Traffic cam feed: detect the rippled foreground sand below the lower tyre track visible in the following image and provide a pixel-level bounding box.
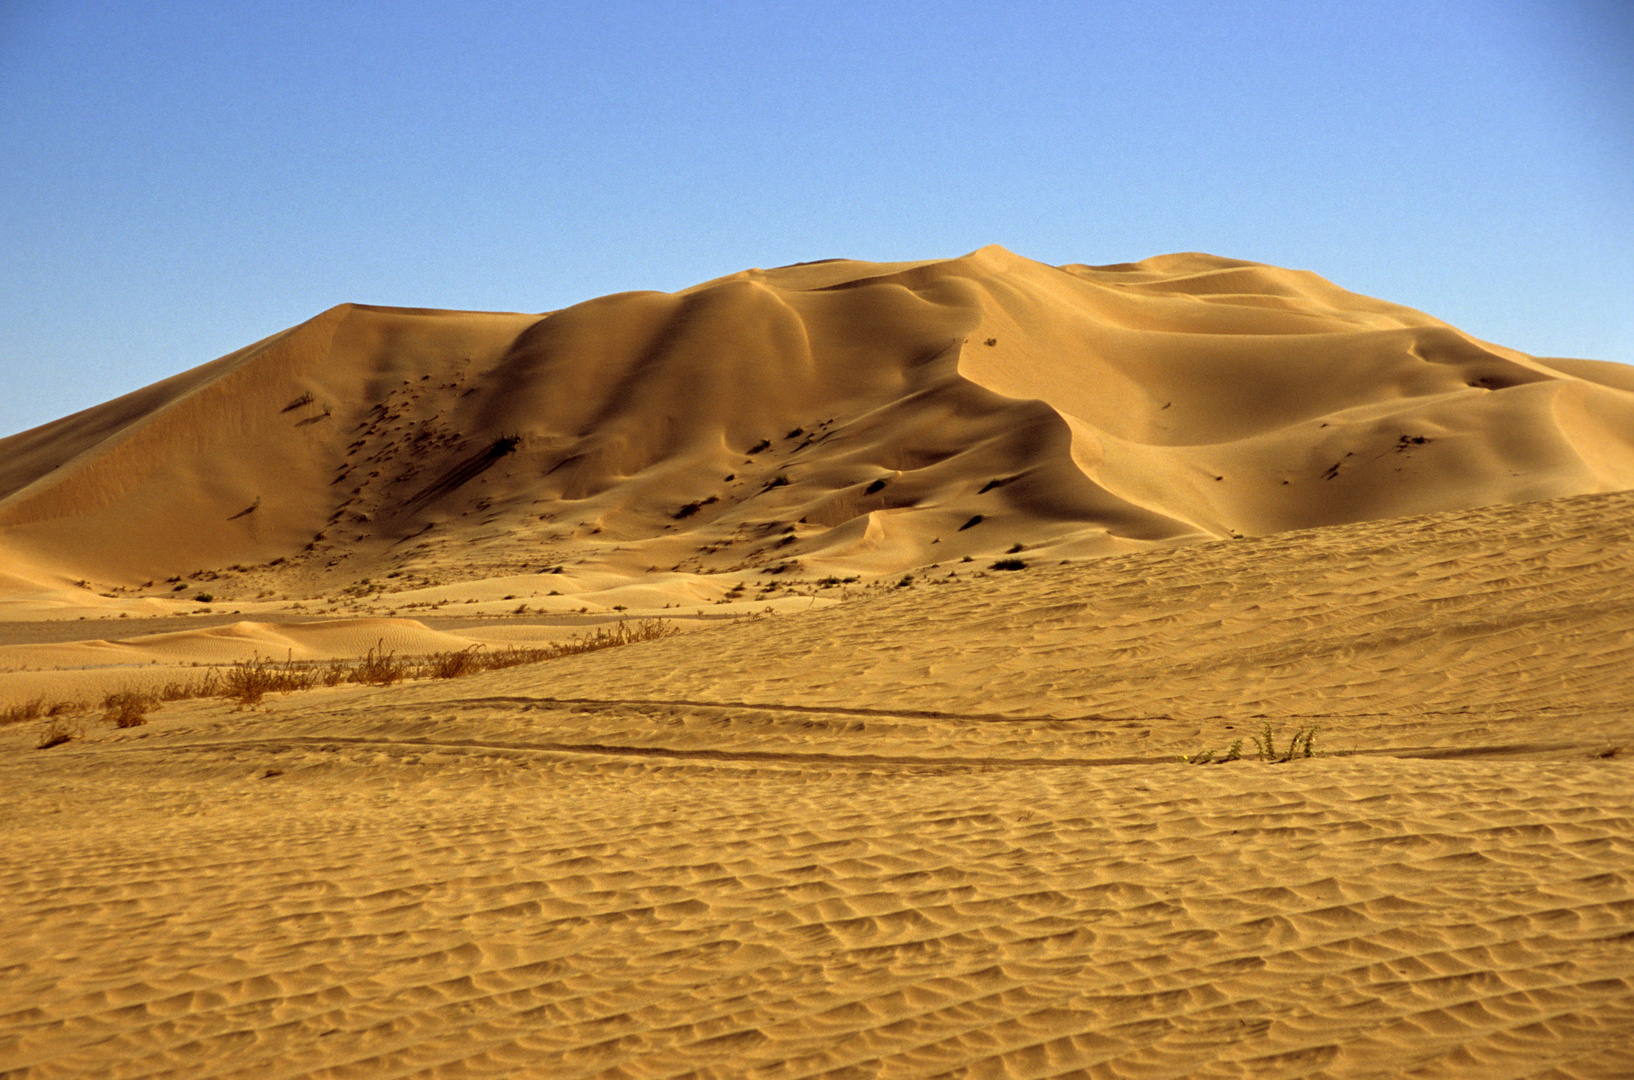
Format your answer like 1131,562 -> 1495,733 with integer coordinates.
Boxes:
0,754 -> 1634,1078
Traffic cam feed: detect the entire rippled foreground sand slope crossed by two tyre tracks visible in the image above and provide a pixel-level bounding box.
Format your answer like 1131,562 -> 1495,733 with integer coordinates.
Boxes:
0,493 -> 1634,1080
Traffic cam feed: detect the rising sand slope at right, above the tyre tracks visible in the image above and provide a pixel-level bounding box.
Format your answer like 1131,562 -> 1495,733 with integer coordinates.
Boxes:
450,492 -> 1634,748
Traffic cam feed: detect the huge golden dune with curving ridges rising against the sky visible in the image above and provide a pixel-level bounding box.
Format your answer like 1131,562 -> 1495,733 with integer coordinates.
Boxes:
0,247 -> 1634,594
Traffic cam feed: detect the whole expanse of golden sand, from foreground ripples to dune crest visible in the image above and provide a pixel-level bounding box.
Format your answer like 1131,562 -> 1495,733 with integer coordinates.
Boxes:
0,248 -> 1634,1080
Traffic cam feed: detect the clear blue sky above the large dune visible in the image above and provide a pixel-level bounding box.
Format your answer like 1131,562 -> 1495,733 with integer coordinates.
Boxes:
0,0 -> 1634,435
